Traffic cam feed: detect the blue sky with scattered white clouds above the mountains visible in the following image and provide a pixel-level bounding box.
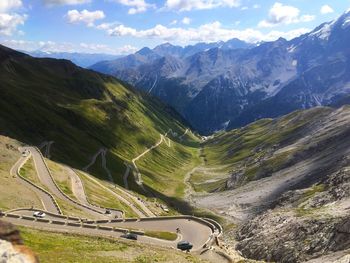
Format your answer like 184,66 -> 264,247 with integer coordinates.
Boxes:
0,0 -> 350,55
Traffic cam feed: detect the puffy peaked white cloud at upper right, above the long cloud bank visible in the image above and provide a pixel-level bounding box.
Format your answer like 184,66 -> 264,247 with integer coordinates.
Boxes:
258,2 -> 315,27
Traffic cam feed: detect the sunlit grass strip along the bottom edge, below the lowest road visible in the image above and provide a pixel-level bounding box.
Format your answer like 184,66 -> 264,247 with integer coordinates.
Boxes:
20,227 -> 207,263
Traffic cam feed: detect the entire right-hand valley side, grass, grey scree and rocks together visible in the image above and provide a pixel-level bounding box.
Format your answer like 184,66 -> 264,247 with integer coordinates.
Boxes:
189,106 -> 350,262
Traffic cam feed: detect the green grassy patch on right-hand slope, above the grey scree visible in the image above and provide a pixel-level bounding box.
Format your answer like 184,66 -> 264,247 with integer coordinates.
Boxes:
198,108 -> 332,192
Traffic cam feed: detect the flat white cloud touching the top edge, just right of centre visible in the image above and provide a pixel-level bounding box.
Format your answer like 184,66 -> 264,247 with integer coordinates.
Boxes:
164,0 -> 240,12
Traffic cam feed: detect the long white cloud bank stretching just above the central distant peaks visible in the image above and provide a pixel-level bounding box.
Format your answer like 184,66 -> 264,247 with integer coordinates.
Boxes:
103,21 -> 310,44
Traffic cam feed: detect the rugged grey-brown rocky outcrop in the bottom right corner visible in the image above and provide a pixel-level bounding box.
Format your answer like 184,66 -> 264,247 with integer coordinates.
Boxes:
237,168 -> 350,262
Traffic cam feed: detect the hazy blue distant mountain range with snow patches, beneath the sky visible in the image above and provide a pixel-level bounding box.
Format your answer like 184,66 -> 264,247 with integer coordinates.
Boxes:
91,11 -> 350,134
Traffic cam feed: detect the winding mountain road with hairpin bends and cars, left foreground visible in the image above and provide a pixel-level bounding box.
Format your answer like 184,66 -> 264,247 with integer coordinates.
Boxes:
6,147 -> 216,253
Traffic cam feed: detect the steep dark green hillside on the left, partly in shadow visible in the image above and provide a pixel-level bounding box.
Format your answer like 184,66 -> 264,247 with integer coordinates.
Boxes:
0,44 -> 198,204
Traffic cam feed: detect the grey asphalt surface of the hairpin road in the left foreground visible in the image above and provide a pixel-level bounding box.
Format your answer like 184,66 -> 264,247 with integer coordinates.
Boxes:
3,147 -> 217,250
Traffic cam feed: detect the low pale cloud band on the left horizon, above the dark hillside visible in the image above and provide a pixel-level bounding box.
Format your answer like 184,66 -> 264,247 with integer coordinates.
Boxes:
1,39 -> 138,55
